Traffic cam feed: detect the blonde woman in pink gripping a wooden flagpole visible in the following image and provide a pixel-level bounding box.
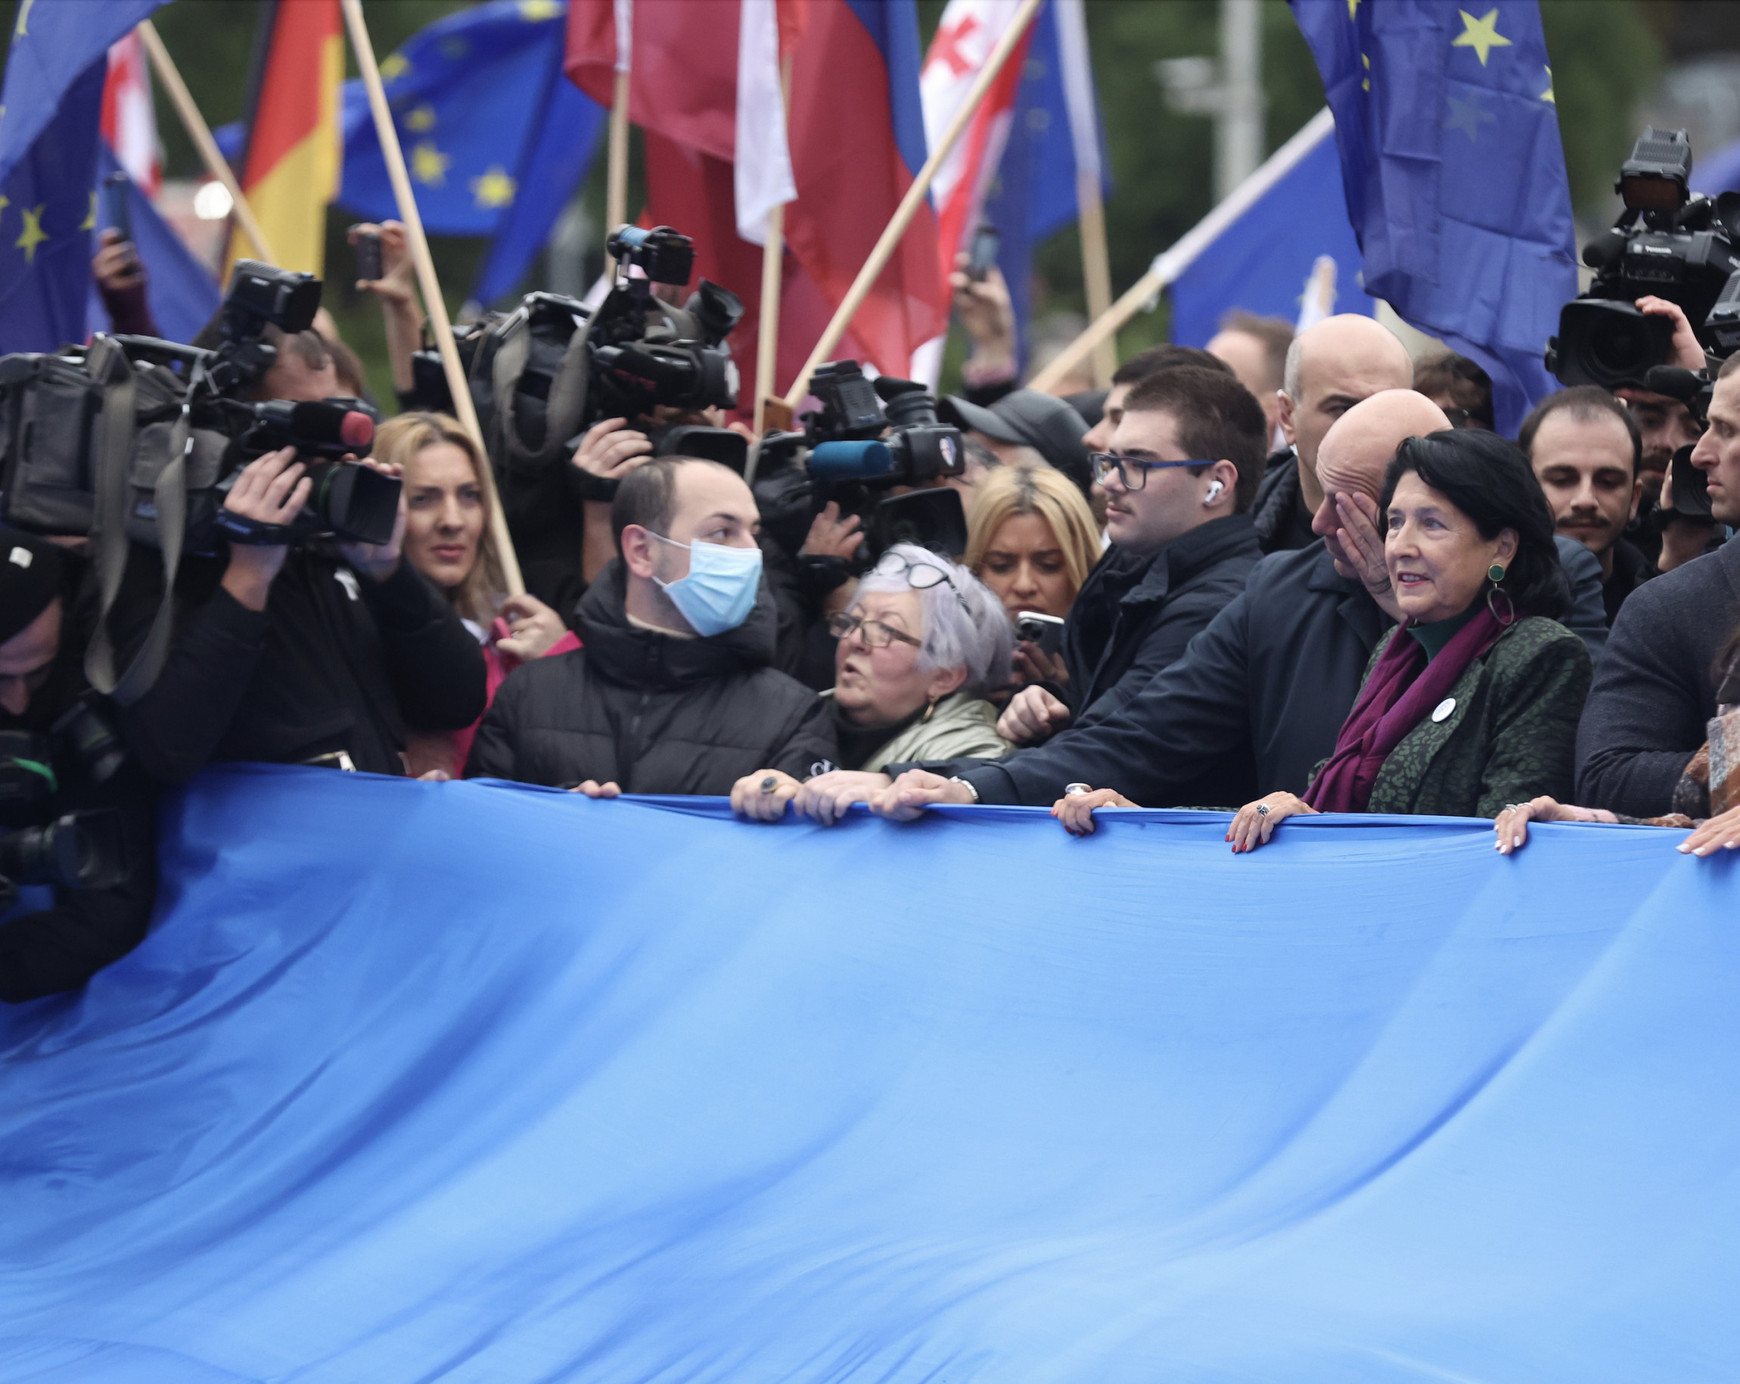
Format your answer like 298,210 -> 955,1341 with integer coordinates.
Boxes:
374,413 -> 579,778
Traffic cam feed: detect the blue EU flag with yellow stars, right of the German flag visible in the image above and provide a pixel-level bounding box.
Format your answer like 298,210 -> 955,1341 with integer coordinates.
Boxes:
339,0 -> 606,303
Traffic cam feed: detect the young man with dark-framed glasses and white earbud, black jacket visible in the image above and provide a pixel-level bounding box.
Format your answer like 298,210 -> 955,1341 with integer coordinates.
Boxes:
997,366 -> 1267,745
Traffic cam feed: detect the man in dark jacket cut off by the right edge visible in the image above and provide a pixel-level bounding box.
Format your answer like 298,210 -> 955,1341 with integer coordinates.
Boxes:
1576,355 -> 1740,816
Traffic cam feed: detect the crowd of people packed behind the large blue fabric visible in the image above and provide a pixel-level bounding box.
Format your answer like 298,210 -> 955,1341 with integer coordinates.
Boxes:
0,225 -> 1740,1001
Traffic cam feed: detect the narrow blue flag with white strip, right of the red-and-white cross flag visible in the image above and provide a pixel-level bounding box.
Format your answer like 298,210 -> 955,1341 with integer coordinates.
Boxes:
981,0 -> 1112,362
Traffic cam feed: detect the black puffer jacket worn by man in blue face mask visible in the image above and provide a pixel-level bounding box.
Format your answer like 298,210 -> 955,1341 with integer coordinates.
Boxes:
465,559 -> 835,794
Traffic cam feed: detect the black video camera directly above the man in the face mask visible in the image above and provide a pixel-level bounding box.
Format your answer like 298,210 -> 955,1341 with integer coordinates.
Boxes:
412,226 -> 746,474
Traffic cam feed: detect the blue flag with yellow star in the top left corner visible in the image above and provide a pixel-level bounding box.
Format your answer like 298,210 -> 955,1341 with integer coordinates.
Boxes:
0,0 -> 162,353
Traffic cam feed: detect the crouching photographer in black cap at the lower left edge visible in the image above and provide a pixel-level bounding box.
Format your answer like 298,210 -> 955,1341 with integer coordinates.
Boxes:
0,529 -> 157,1003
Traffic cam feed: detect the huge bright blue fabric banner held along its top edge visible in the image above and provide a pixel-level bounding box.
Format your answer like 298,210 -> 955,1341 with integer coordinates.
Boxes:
0,769 -> 1740,1384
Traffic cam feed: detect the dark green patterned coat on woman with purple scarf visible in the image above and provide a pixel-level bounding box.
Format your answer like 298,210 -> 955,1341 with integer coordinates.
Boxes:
1314,616 -> 1594,816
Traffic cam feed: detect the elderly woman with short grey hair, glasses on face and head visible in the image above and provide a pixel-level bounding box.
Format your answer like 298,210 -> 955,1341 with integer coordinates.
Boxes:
731,543 -> 1014,823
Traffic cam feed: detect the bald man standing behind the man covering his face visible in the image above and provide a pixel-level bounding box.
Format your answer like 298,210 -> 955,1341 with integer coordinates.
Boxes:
1251,313 -> 1413,552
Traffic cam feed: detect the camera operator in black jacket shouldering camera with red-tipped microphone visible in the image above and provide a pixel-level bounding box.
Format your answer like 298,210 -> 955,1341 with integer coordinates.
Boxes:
110,447 -> 487,783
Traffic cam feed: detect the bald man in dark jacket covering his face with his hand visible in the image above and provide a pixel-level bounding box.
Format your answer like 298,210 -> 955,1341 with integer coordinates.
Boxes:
870,390 -> 1606,818
